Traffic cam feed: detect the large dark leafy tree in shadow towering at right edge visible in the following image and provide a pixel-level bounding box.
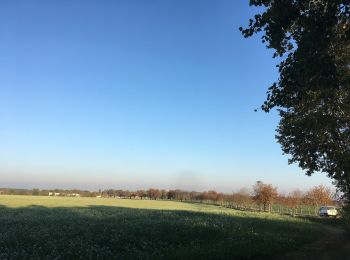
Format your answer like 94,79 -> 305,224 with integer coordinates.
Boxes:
240,0 -> 350,203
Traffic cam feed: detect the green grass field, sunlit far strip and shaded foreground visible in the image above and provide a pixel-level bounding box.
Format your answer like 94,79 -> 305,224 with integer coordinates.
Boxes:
0,195 -> 328,259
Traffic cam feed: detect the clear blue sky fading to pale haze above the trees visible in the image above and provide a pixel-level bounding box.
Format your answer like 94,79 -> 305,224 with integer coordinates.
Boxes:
0,0 -> 331,192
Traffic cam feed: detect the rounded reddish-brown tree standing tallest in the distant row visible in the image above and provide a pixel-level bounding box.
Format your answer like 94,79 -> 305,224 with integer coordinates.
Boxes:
253,181 -> 278,212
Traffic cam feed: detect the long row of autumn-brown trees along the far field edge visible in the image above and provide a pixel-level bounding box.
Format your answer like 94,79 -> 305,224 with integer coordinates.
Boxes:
0,181 -> 335,215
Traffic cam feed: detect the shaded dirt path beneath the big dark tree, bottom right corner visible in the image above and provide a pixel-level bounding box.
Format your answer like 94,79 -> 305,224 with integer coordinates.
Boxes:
277,226 -> 350,260
